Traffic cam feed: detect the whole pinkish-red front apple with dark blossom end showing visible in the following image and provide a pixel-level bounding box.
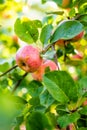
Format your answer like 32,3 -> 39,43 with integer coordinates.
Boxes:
16,45 -> 42,72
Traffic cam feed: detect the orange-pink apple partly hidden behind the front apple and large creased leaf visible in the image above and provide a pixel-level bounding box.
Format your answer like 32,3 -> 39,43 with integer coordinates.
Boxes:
32,60 -> 58,81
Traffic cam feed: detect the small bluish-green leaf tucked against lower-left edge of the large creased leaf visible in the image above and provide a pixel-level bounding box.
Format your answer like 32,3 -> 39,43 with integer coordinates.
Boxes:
40,90 -> 54,108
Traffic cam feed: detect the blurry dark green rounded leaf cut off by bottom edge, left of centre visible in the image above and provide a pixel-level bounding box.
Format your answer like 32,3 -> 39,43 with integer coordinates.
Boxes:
26,112 -> 52,130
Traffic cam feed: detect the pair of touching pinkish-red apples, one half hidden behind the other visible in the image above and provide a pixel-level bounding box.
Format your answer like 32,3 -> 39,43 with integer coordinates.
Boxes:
16,45 -> 58,81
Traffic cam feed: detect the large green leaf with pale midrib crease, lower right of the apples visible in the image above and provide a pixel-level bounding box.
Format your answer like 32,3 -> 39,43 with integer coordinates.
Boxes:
43,71 -> 78,103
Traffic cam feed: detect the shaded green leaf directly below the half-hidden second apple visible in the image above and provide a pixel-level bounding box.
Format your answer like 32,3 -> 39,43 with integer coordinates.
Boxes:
27,80 -> 43,97
